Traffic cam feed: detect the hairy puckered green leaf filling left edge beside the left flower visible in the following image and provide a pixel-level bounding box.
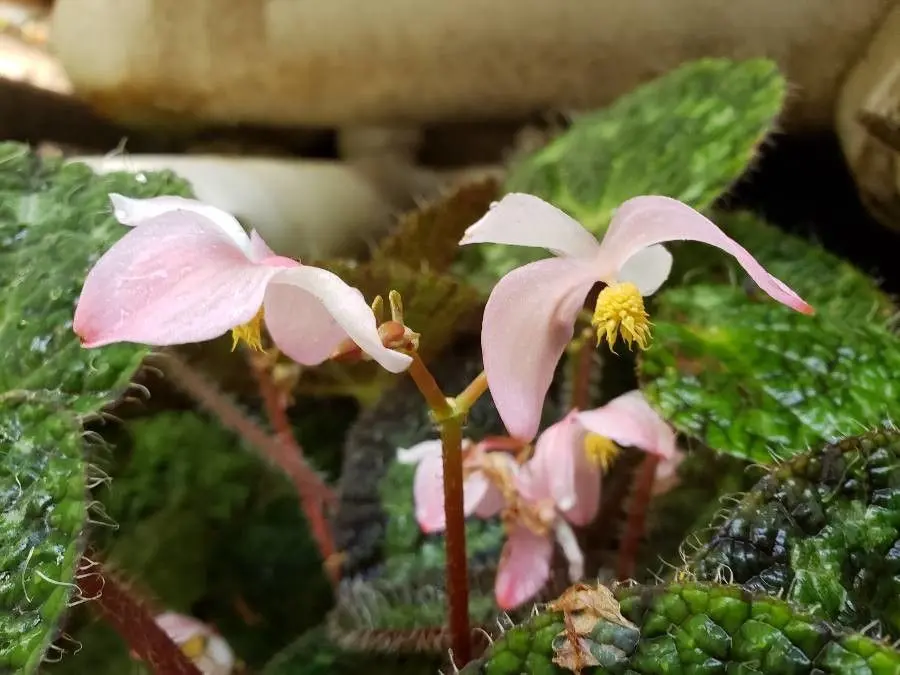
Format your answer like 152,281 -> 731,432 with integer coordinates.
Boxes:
0,143 -> 195,673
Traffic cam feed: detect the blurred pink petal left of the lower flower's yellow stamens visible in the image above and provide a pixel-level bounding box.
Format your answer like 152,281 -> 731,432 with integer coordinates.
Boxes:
519,411 -> 600,525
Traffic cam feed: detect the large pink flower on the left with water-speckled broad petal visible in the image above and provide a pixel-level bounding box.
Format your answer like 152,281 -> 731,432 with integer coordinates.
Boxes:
73,194 -> 411,373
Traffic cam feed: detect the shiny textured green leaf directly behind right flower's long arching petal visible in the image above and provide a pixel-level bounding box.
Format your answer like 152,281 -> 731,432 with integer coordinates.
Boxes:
639,214 -> 900,463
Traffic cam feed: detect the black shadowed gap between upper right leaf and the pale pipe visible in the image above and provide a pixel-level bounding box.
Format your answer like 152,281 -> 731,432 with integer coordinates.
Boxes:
722,133 -> 900,294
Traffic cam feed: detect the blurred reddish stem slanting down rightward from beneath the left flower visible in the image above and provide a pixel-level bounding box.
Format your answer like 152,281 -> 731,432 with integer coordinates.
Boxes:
156,352 -> 338,579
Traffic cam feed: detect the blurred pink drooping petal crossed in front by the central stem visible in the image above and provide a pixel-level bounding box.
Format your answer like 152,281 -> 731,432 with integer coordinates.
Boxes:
413,448 -> 503,534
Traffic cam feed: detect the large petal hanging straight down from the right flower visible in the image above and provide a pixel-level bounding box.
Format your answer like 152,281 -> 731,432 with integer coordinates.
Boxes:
481,258 -> 597,442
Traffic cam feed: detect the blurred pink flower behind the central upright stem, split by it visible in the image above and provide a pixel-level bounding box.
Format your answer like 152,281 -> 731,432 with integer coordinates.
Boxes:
397,439 -> 515,534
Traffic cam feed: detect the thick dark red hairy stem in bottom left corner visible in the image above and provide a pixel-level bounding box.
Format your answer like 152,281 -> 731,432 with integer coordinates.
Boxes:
76,551 -> 202,675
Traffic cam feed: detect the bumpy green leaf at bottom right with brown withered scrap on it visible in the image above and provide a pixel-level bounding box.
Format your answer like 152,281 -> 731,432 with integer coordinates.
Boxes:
460,583 -> 900,675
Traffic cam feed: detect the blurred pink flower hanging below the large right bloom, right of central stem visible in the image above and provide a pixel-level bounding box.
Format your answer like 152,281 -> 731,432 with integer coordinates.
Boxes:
495,391 -> 680,609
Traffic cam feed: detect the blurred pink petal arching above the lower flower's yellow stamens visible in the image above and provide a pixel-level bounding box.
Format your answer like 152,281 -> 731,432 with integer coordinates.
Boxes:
578,389 -> 676,458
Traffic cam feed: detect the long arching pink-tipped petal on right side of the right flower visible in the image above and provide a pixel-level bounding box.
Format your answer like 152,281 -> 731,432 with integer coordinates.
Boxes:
601,196 -> 814,314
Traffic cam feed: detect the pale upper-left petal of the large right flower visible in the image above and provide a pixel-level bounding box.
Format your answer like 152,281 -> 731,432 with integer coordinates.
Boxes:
459,192 -> 600,258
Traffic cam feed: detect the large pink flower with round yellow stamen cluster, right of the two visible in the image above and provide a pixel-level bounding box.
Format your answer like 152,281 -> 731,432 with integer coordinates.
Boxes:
460,193 -> 813,441
